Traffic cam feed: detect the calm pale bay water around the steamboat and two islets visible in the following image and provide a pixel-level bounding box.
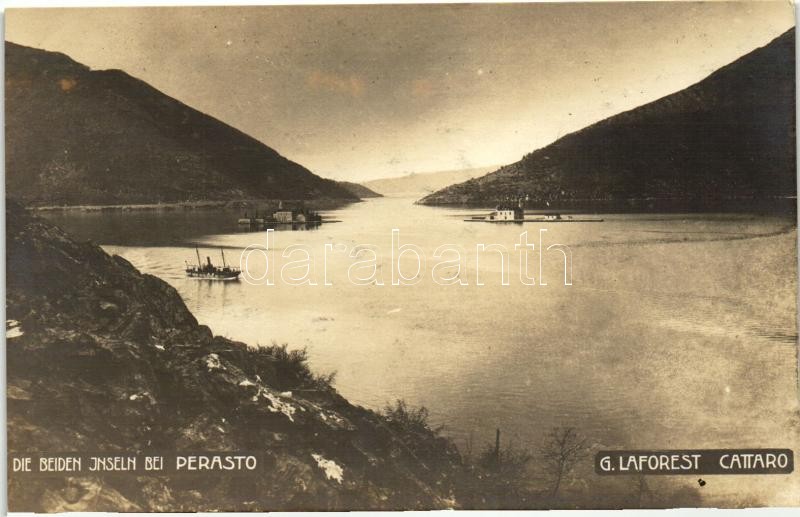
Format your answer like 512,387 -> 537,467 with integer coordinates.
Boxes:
47,198 -> 800,504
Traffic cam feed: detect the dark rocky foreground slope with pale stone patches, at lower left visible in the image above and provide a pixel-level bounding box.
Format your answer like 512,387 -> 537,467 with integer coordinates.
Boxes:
6,202 -> 461,512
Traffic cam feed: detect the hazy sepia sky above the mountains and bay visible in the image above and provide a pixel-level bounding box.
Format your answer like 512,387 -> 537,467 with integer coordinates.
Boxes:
6,1 -> 794,180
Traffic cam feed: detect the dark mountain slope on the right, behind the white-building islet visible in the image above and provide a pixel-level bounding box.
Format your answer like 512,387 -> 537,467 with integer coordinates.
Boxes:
420,29 -> 796,210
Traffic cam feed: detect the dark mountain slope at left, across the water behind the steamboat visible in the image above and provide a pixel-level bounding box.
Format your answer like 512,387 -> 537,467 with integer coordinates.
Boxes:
6,42 -> 355,204
